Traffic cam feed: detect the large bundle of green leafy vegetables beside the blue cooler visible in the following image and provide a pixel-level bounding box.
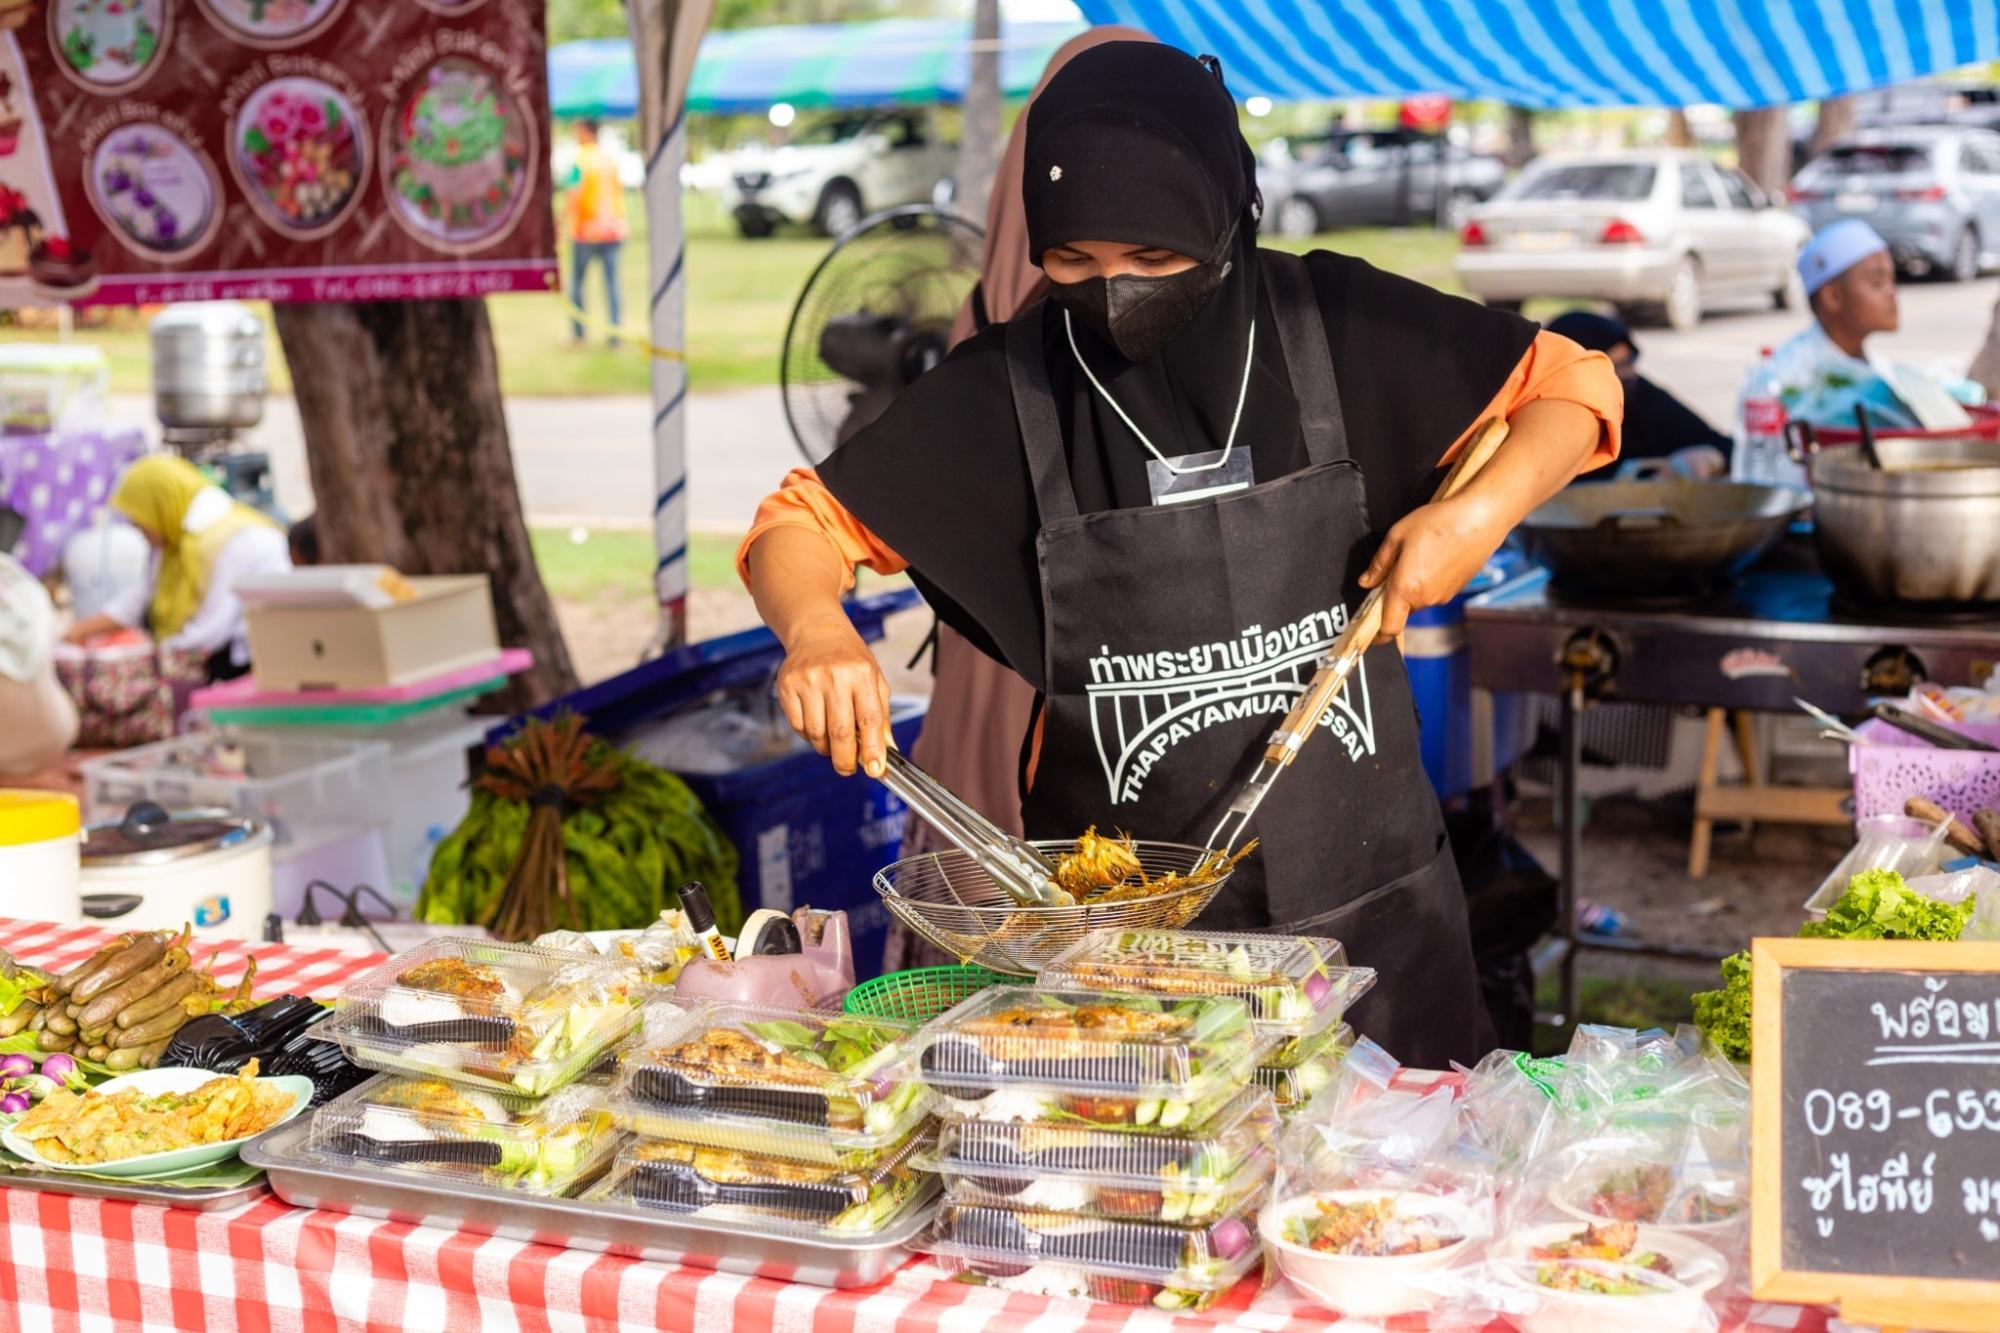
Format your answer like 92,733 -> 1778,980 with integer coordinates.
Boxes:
416,719 -> 742,939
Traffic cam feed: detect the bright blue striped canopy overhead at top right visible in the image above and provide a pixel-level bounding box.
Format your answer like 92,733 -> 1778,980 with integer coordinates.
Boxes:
1078,0 -> 2000,108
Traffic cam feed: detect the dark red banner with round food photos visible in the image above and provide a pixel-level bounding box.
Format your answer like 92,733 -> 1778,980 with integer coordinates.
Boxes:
0,0 -> 556,306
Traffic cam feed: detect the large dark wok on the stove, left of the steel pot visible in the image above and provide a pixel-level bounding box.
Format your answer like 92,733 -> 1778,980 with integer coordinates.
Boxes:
1520,480 -> 1812,596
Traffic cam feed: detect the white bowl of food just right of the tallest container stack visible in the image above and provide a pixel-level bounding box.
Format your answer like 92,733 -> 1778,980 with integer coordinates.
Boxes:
1258,1189 -> 1482,1319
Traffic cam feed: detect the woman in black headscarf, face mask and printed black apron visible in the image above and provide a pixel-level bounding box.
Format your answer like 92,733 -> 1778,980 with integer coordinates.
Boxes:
738,42 -> 1620,1067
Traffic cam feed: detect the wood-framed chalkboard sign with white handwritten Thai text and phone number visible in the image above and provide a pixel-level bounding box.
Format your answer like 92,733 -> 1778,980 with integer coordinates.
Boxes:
1750,941 -> 2000,1329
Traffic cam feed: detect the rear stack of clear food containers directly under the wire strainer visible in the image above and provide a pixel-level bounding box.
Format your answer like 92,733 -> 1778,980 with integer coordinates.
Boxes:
1040,931 -> 1376,1119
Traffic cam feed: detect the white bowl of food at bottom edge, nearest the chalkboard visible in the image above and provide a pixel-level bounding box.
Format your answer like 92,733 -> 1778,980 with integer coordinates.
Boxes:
1496,1223 -> 1728,1333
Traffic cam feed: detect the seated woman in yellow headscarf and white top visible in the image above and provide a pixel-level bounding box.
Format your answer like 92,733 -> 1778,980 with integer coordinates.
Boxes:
66,454 -> 292,681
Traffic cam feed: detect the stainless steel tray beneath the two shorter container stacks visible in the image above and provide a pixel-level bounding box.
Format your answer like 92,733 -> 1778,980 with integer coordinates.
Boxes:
244,1121 -> 936,1287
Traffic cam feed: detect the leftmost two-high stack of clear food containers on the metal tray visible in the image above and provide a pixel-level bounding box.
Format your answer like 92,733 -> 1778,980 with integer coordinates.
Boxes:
306,939 -> 660,1197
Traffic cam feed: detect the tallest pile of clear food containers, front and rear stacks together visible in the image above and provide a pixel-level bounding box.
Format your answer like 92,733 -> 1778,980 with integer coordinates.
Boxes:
922,931 -> 1374,1309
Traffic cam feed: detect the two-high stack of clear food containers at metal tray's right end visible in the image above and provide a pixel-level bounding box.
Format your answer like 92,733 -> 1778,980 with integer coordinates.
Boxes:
590,1005 -> 936,1243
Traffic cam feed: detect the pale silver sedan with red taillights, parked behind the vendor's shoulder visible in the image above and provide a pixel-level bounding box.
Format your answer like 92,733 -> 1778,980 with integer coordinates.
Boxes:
1454,148 -> 1810,328
